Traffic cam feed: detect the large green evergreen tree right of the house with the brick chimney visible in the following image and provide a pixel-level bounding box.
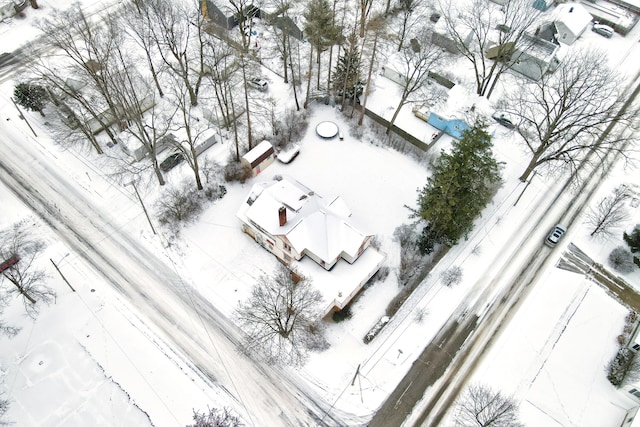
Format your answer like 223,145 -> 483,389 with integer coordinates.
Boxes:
414,122 -> 501,253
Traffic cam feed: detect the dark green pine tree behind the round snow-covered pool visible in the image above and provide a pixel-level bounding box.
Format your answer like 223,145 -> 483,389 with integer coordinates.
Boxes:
333,33 -> 364,104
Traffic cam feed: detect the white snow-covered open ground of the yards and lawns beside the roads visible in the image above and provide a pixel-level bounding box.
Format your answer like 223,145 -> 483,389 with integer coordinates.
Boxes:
0,0 -> 640,427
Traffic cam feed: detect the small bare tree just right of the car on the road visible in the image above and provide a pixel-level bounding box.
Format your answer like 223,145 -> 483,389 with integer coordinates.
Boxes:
586,186 -> 629,237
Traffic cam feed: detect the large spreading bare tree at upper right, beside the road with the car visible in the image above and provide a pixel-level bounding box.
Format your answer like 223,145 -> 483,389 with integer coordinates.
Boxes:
505,50 -> 631,181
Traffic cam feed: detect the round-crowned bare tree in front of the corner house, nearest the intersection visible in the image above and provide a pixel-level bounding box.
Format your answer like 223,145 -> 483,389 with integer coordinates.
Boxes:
236,265 -> 328,365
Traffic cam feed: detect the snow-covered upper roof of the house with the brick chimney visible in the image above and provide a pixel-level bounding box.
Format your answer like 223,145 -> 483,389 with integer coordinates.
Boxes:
238,177 -> 371,264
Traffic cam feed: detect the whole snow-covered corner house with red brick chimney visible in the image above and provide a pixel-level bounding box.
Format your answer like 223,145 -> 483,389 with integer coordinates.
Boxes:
237,177 -> 385,313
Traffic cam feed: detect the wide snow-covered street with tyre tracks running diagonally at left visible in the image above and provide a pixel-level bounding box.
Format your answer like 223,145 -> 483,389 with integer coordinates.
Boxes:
0,122 -> 346,427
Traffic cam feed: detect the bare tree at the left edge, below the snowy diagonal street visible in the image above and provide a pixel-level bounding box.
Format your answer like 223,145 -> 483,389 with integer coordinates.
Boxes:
0,221 -> 55,317
